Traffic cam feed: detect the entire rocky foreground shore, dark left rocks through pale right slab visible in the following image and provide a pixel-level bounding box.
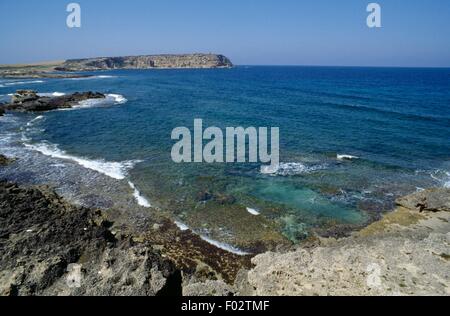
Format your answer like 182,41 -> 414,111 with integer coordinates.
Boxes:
0,152 -> 450,296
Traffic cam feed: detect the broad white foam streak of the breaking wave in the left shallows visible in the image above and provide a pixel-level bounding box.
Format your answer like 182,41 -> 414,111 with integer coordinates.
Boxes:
24,142 -> 140,180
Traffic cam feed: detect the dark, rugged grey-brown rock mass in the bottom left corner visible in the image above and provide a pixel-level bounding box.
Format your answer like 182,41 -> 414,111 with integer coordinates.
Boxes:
0,181 -> 181,295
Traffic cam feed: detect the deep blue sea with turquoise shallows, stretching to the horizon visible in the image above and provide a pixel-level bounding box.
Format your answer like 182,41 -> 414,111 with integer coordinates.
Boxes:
0,66 -> 450,248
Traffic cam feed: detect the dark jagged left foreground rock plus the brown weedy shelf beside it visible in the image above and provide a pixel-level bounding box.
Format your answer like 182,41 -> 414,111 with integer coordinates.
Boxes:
0,181 -> 250,296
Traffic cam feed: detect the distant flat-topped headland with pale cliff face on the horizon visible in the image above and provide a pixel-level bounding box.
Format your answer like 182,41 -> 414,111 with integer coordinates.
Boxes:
56,54 -> 233,71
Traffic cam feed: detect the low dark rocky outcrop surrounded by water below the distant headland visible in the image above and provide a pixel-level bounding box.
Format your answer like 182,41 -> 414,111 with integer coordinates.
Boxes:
4,90 -> 105,112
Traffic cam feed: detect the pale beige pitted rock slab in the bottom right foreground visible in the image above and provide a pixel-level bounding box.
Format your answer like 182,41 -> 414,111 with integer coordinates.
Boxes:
232,189 -> 450,296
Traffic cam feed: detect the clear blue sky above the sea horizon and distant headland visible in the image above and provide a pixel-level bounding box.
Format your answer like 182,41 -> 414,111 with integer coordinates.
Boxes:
0,0 -> 450,67
